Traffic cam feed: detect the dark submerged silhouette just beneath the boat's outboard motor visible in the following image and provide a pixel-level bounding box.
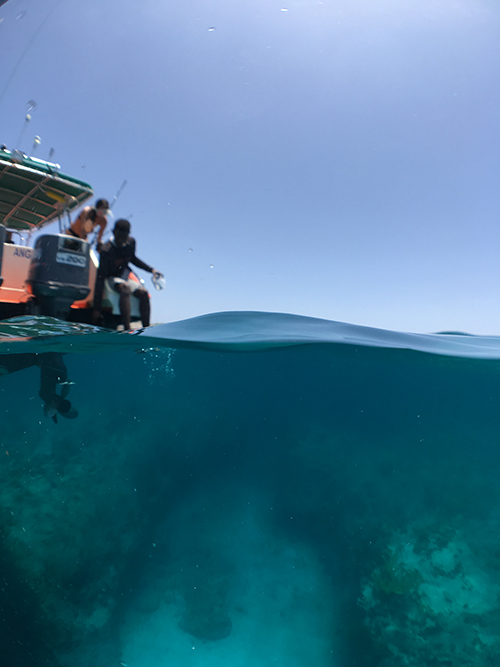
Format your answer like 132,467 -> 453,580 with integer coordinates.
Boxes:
0,352 -> 78,424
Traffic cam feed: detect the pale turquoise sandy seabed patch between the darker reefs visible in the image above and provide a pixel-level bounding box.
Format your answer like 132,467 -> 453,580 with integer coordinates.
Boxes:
121,488 -> 338,667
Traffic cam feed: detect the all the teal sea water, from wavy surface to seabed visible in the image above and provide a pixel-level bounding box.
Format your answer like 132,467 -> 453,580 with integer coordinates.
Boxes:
0,313 -> 500,667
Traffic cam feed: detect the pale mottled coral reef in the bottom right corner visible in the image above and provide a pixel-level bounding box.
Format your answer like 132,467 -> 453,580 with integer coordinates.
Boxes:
359,525 -> 500,667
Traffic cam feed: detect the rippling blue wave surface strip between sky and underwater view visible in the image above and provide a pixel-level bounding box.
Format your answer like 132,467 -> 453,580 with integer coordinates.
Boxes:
0,311 -> 500,359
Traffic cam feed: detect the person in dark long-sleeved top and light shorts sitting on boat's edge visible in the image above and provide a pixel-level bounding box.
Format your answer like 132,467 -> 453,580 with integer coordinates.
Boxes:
92,218 -> 163,330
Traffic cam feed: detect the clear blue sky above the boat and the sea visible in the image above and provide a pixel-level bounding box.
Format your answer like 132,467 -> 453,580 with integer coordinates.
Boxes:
0,0 -> 500,335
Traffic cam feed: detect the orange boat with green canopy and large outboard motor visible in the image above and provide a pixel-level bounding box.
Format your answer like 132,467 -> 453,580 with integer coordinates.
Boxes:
0,147 -> 144,328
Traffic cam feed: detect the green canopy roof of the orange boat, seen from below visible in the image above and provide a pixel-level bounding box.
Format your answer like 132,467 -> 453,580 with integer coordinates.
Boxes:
0,150 -> 94,231
